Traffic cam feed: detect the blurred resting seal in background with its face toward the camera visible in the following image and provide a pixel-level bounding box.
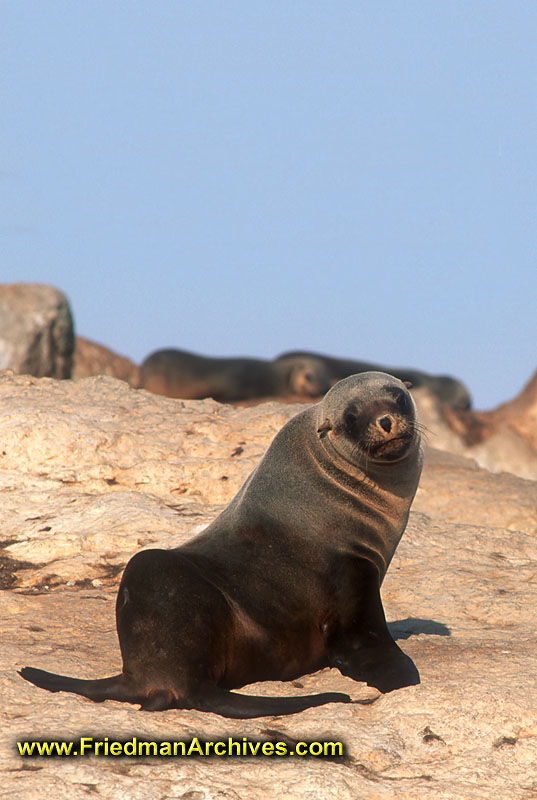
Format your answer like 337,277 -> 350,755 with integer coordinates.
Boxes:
139,349 -> 332,403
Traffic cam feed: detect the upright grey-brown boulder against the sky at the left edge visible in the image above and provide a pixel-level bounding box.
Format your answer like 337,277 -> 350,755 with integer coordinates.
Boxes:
0,283 -> 74,379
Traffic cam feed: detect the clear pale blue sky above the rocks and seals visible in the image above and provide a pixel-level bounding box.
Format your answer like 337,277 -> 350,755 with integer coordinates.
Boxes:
0,0 -> 537,408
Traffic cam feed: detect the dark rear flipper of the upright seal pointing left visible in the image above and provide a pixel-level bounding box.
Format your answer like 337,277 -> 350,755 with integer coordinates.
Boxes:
19,667 -> 142,703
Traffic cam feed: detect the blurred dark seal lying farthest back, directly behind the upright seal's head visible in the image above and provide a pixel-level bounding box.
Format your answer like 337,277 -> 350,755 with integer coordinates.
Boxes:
275,350 -> 472,410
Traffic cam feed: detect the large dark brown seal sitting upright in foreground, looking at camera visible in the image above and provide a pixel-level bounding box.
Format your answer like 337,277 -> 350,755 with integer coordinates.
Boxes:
20,372 -> 422,718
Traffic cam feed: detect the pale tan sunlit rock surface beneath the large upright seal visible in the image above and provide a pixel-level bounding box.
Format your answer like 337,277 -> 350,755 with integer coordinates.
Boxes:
0,374 -> 537,800
